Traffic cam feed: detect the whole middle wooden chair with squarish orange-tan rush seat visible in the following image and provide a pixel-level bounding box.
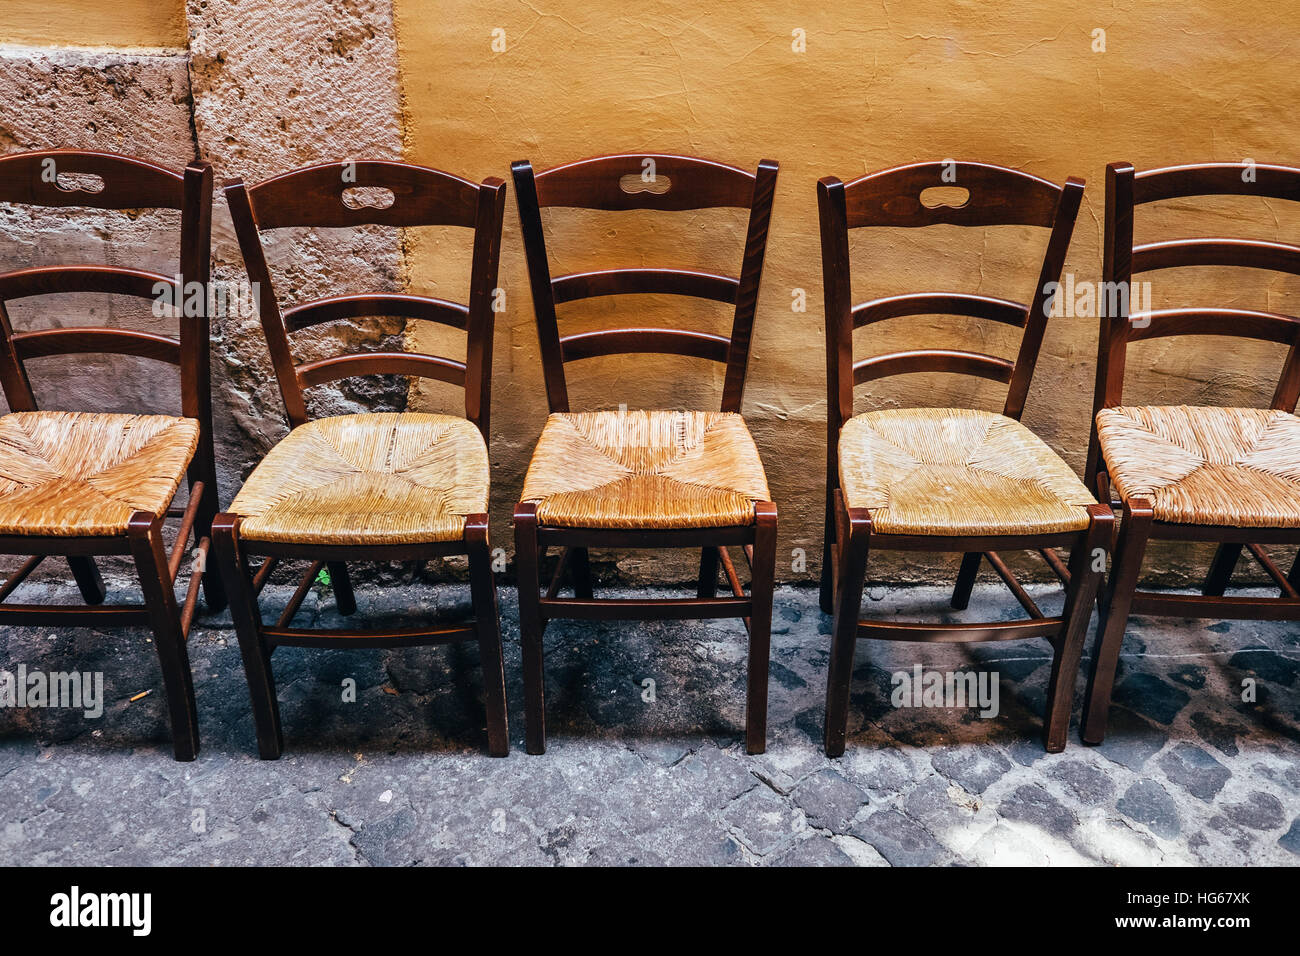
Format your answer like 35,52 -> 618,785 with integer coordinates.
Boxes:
512,153 -> 777,753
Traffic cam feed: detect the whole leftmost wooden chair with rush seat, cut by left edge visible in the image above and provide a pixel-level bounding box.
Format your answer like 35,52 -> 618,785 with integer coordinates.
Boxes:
0,150 -> 225,760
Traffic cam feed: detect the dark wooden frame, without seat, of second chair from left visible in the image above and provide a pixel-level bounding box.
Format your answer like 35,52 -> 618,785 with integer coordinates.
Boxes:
212,160 -> 510,760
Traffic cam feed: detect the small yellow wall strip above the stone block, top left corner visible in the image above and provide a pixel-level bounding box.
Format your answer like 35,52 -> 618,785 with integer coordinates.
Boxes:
0,0 -> 186,47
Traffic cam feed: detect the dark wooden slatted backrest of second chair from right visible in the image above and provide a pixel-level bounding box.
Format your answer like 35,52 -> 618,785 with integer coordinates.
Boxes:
818,160 -> 1084,440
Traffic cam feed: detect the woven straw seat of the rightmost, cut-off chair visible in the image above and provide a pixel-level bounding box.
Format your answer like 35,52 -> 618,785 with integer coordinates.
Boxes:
1097,406 -> 1300,528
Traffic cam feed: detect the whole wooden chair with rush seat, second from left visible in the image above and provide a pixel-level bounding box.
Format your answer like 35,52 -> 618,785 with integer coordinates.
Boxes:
213,161 -> 510,760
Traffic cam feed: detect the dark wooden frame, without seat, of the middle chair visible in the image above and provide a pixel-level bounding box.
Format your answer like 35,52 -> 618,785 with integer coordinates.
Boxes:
512,153 -> 777,754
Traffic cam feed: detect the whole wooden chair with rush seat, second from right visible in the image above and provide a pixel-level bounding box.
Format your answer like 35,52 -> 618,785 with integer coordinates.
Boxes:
818,163 -> 1113,757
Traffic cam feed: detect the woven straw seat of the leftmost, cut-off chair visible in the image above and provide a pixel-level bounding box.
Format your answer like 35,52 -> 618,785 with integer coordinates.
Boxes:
0,411 -> 199,537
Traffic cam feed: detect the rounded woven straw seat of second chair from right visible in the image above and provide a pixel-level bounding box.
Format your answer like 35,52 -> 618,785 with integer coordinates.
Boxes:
840,408 -> 1096,535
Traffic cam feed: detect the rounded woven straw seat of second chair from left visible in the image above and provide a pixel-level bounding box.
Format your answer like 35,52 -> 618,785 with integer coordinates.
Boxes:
230,412 -> 488,545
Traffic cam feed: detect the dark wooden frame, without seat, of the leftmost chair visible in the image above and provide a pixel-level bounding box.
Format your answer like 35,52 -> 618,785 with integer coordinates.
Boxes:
0,150 -> 226,761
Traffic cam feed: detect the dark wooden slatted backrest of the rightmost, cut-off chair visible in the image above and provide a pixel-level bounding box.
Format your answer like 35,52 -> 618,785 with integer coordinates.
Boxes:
1093,163 -> 1300,416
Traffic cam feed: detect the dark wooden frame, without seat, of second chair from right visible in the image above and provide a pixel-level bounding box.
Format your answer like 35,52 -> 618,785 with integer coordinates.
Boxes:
818,163 -> 1114,757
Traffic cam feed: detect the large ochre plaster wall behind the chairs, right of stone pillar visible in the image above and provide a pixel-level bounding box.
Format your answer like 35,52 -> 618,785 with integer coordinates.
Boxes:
395,0 -> 1300,587
